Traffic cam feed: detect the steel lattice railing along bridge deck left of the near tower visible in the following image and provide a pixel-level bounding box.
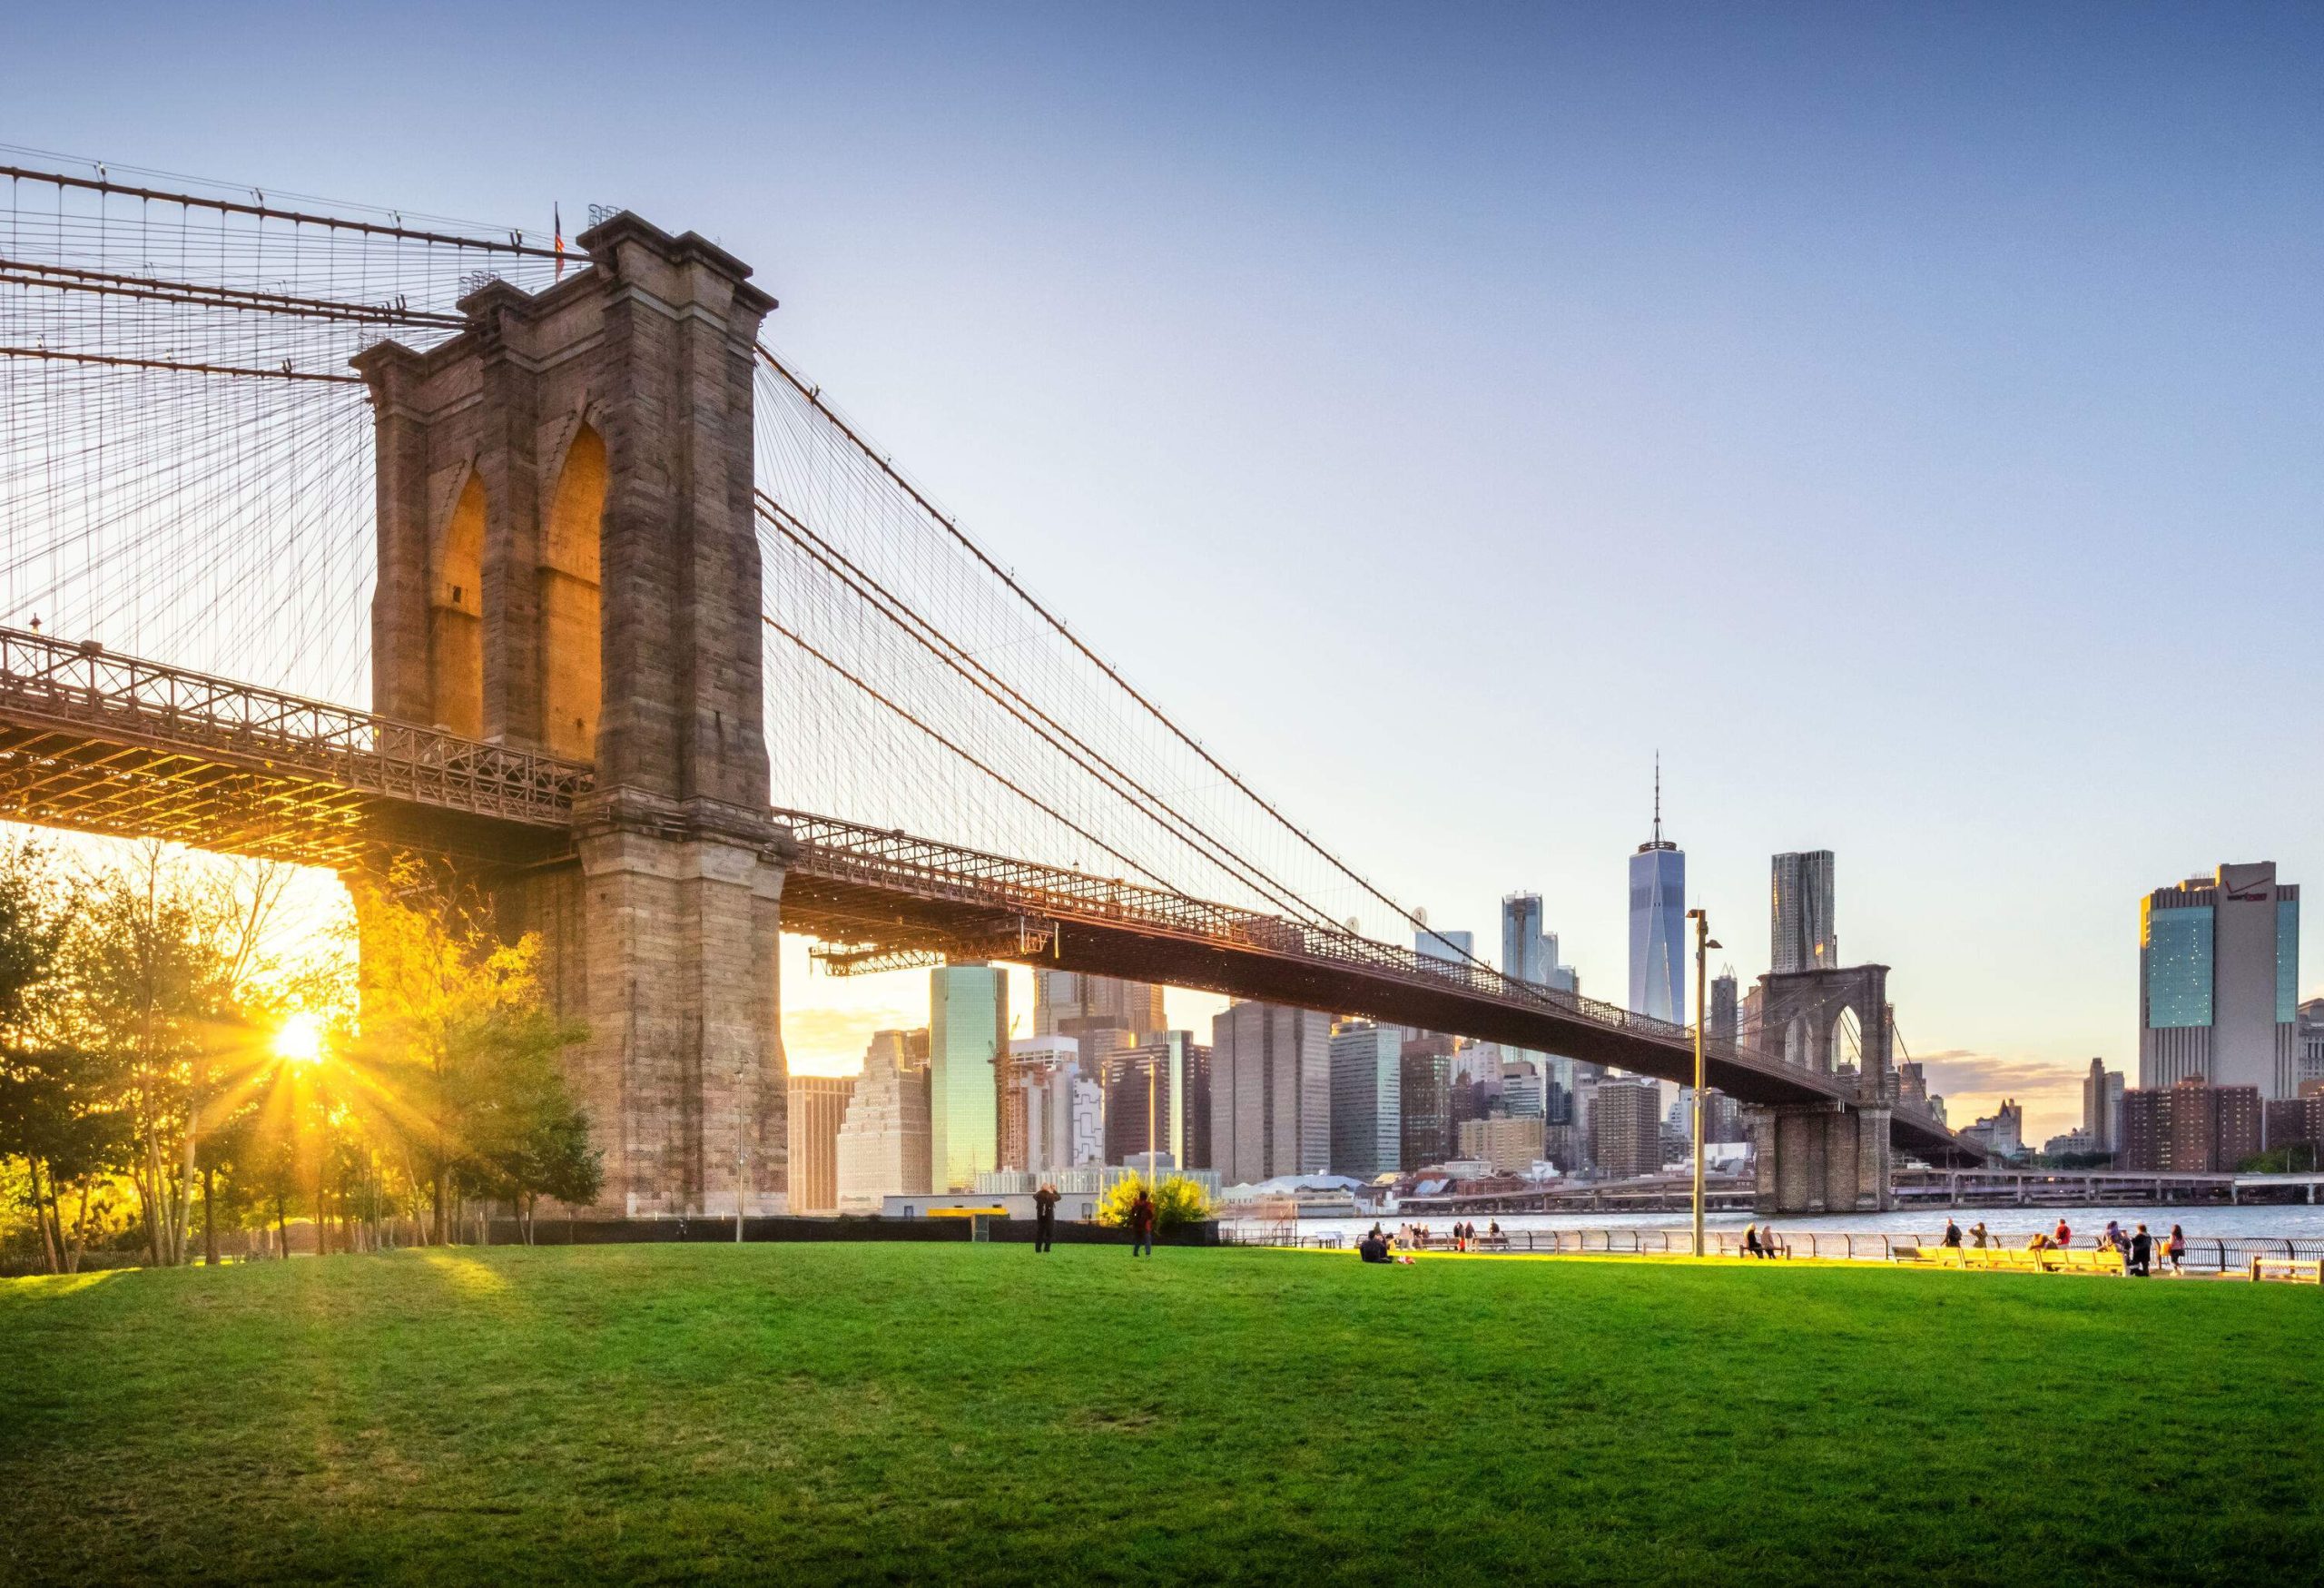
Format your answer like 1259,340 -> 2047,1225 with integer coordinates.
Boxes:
0,627 -> 595,828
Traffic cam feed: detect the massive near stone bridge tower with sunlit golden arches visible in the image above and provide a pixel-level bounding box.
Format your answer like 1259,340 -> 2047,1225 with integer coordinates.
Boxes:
356,214 -> 785,1216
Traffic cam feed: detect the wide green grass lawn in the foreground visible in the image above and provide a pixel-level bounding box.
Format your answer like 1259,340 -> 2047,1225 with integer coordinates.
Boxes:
0,1244 -> 2324,1585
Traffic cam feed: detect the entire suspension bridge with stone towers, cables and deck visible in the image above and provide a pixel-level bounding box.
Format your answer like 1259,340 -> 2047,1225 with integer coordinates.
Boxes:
0,167 -> 1980,1216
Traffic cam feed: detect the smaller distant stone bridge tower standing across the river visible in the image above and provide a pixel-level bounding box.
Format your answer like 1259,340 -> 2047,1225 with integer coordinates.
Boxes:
1746,965 -> 1896,1214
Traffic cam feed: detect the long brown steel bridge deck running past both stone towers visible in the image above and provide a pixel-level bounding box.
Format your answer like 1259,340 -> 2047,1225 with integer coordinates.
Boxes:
0,627 -> 1980,1162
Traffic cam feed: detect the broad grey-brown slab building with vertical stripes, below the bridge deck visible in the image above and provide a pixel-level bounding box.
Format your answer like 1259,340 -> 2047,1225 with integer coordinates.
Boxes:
1211,1004 -> 1332,1186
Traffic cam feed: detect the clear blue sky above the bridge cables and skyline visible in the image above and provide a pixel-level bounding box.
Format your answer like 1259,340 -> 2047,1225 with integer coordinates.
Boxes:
0,5 -> 2324,1132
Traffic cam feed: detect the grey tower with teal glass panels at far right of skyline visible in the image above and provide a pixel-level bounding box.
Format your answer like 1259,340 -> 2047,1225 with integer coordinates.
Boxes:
2138,860 -> 2300,1098
